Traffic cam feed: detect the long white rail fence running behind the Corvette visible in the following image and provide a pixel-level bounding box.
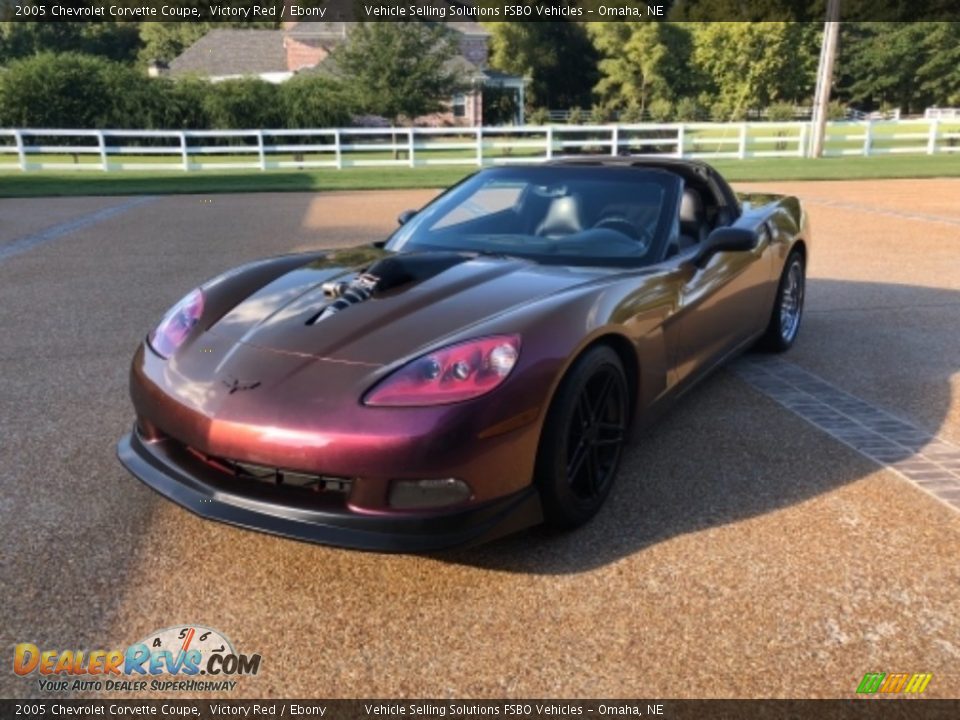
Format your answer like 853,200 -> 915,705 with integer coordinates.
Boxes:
0,118 -> 960,171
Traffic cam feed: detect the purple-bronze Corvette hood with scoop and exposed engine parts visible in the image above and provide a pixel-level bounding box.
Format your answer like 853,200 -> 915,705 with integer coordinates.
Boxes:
207,248 -> 609,365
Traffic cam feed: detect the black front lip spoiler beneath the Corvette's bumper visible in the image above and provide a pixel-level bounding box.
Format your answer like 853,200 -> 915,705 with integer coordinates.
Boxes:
117,429 -> 543,552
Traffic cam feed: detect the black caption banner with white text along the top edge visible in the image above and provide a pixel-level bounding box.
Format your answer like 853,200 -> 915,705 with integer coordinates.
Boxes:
0,0 -> 960,23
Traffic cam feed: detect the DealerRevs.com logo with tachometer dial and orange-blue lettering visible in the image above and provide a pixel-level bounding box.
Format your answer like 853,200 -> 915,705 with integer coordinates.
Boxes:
13,625 -> 261,692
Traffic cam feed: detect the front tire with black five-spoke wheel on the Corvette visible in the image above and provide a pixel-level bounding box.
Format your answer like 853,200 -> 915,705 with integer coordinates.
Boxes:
535,345 -> 629,529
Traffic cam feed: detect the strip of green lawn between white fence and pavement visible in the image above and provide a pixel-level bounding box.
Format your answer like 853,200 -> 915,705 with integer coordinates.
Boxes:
0,153 -> 960,198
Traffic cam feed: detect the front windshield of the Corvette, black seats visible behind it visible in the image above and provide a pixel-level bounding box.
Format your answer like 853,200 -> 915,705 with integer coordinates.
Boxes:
387,166 -> 681,267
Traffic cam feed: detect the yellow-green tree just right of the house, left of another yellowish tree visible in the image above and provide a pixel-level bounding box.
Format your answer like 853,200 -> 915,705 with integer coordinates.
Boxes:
589,21 -> 694,112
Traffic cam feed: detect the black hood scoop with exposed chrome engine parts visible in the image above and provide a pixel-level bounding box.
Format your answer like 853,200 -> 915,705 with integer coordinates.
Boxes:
306,252 -> 470,325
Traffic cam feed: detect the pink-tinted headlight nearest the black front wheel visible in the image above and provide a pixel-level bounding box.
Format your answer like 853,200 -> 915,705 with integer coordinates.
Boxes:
363,335 -> 520,407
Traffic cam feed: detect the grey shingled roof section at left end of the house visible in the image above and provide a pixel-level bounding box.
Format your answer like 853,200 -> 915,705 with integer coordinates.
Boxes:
170,28 -> 287,77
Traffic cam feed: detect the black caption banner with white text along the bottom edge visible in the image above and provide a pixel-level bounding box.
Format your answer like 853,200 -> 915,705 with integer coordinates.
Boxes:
0,698 -> 960,720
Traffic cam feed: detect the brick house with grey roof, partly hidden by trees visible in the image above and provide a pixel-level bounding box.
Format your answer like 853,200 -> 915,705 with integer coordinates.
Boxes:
168,22 -> 526,126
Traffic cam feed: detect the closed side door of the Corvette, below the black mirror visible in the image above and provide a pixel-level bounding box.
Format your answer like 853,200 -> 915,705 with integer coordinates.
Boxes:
676,220 -> 772,381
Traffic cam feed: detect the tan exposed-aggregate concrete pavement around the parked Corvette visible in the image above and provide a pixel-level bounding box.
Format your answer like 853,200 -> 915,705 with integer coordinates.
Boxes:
0,180 -> 960,697
